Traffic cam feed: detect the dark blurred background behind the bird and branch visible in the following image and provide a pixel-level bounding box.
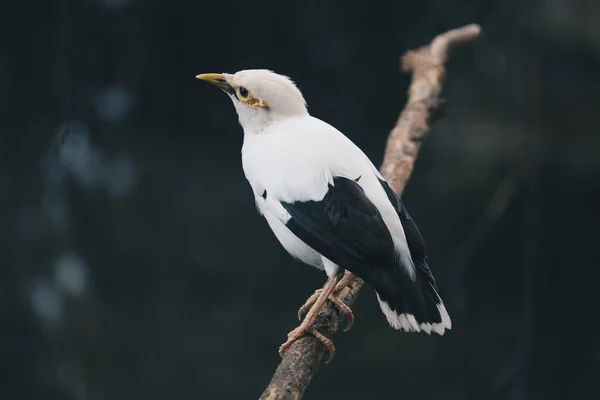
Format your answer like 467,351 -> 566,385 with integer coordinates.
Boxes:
0,0 -> 600,400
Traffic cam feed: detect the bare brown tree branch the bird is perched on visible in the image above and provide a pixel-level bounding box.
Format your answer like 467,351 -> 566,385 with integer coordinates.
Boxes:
260,24 -> 481,400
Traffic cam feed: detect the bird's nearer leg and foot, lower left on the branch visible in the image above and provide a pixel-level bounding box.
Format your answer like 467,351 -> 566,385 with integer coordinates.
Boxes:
279,276 -> 341,362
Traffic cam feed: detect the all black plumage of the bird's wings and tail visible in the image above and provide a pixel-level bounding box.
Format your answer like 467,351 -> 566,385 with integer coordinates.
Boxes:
281,177 -> 448,323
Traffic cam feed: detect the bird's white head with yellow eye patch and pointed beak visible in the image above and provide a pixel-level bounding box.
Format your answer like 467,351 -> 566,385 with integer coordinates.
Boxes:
196,69 -> 308,131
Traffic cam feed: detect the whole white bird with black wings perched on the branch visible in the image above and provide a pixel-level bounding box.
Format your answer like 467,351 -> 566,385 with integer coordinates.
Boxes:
197,69 -> 452,360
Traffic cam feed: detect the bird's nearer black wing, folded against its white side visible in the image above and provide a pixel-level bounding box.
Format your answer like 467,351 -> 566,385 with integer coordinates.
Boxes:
281,177 -> 399,296
